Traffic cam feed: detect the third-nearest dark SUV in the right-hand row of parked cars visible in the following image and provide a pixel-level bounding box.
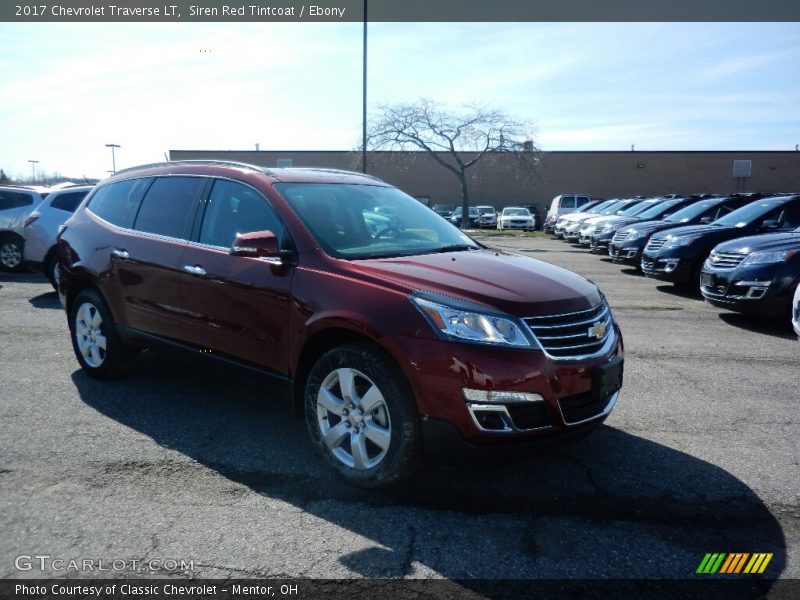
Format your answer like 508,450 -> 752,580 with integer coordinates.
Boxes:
608,194 -> 765,268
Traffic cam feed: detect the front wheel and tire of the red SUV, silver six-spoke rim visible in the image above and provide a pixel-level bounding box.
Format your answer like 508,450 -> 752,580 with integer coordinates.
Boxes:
305,343 -> 422,488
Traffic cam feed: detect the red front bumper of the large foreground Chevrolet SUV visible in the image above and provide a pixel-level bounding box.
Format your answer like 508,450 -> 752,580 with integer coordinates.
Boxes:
394,325 -> 623,447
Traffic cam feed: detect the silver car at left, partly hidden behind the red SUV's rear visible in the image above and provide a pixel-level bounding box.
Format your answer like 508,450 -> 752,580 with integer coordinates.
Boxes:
24,185 -> 93,287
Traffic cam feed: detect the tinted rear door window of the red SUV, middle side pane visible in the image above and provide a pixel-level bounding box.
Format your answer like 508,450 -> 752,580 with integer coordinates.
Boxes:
133,177 -> 208,239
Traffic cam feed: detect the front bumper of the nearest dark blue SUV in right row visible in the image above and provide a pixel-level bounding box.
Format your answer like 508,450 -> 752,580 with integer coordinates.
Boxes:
700,265 -> 794,318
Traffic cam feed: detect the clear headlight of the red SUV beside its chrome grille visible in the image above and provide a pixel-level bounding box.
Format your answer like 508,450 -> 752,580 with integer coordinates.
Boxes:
411,295 -> 531,348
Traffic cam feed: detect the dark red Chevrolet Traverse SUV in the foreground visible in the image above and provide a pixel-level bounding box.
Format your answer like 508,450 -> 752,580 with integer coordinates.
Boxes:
58,161 -> 623,487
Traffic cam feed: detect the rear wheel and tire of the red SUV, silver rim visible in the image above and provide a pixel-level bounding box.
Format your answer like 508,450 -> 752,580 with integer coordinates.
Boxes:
69,289 -> 135,379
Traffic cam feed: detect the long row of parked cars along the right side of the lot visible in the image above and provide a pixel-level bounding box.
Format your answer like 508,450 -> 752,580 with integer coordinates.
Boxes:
545,193 -> 800,336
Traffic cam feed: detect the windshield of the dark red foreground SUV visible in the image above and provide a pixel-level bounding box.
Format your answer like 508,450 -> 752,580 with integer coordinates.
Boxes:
275,183 -> 481,259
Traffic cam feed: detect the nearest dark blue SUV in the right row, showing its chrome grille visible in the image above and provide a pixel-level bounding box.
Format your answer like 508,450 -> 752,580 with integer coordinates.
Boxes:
700,228 -> 800,319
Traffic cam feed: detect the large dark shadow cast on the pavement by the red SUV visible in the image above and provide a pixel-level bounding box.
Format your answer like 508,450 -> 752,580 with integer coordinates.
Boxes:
72,351 -> 786,598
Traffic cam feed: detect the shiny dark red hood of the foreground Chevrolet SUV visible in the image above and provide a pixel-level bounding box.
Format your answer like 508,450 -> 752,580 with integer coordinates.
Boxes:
352,249 -> 600,317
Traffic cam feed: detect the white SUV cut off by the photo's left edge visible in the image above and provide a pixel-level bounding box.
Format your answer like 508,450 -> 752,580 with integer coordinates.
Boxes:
0,185 -> 50,271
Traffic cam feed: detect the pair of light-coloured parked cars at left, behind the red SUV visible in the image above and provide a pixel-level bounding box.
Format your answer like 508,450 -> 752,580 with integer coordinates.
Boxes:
0,183 -> 93,287
